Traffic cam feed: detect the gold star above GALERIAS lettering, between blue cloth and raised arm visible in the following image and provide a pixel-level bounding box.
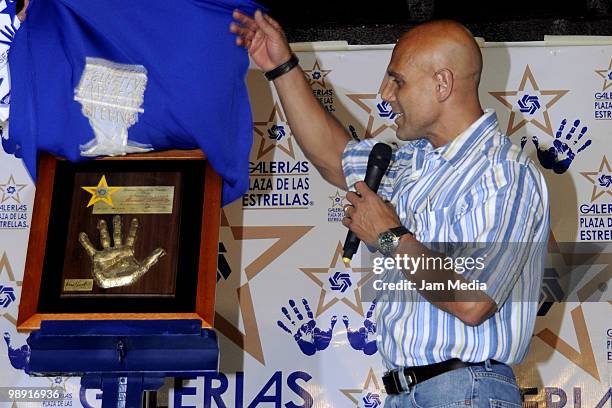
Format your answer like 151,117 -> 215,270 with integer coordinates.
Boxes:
253,102 -> 295,160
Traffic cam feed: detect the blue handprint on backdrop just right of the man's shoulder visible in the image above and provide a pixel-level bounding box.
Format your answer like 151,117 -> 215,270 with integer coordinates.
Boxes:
521,119 -> 591,174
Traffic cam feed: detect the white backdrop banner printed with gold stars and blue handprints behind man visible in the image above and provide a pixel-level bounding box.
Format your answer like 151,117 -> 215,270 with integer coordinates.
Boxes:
0,43 -> 612,408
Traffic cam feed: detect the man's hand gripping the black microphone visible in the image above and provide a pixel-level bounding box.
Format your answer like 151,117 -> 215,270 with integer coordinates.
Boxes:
342,181 -> 402,247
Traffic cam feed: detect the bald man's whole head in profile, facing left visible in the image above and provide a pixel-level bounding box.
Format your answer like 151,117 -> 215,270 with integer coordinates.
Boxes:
382,20 -> 482,146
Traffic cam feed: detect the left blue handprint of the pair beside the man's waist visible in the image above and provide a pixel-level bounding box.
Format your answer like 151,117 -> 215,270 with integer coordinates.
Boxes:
276,299 -> 338,356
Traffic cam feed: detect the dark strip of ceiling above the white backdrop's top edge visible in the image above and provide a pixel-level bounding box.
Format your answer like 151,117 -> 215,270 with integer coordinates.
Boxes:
260,0 -> 612,44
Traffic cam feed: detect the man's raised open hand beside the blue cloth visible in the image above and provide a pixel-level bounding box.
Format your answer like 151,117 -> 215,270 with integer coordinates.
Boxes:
230,10 -> 291,72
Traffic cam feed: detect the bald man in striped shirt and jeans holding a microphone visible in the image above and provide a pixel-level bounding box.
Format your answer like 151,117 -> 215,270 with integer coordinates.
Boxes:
230,11 -> 549,407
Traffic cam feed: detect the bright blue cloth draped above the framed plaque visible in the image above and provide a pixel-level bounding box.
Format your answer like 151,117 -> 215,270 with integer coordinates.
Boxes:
5,0 -> 260,204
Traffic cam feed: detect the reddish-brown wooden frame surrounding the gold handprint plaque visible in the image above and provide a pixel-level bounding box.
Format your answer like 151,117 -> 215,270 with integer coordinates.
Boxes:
17,150 -> 222,332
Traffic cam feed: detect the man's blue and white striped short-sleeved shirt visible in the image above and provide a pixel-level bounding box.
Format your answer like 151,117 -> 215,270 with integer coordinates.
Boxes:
343,110 -> 549,369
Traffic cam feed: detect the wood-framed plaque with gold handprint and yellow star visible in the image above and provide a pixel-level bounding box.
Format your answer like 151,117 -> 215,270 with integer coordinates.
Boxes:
17,150 -> 221,331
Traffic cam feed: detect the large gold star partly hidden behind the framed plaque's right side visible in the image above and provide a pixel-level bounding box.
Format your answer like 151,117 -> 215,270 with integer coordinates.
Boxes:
215,212 -> 313,365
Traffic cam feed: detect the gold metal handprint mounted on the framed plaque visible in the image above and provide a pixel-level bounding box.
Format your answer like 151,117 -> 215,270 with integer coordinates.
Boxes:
79,215 -> 166,288
